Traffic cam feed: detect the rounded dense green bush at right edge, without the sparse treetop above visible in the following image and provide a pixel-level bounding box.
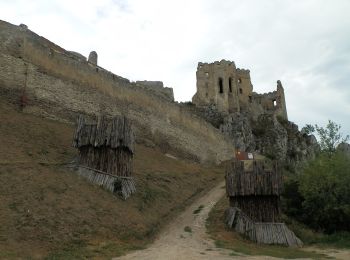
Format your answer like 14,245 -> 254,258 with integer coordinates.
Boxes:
299,152 -> 350,233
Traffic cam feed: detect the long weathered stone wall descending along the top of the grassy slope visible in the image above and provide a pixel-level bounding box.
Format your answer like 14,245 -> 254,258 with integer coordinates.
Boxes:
0,21 -> 234,165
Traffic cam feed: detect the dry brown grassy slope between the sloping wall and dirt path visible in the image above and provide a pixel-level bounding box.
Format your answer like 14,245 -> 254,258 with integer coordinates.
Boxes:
0,98 -> 223,259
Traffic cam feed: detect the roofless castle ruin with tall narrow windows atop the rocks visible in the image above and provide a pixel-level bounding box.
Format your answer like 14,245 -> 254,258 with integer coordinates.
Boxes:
192,60 -> 288,120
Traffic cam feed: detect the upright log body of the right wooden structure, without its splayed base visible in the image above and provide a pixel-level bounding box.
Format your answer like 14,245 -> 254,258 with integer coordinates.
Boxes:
226,161 -> 282,222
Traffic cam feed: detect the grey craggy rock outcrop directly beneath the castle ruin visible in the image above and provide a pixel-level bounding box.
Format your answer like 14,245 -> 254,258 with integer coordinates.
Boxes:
220,113 -> 319,169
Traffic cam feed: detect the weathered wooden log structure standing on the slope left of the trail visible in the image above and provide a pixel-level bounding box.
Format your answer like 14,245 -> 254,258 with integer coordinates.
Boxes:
73,116 -> 136,199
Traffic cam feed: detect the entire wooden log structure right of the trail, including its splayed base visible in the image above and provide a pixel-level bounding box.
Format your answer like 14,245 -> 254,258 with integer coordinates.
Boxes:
226,160 -> 302,246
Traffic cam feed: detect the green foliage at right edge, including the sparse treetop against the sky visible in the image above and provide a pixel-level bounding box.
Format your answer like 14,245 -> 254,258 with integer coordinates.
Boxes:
284,120 -> 350,233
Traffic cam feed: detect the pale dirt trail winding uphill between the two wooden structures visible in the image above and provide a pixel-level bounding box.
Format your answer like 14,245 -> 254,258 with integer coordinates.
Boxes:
116,182 -> 273,260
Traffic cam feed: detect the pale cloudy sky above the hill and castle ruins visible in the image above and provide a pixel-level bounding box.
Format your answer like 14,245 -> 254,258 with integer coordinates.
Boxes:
0,0 -> 350,134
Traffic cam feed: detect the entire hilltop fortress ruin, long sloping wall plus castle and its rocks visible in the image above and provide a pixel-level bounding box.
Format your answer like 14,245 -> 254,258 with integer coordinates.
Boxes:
0,21 -> 315,165
